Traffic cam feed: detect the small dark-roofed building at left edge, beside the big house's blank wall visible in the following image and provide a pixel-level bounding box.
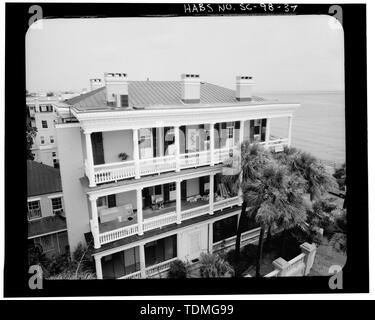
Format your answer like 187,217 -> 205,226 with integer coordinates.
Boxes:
27,160 -> 69,257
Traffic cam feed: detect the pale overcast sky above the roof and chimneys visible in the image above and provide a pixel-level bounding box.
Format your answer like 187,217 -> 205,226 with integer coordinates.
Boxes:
26,15 -> 344,92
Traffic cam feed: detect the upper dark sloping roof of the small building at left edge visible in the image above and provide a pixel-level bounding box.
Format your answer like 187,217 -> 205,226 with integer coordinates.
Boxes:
27,160 -> 62,197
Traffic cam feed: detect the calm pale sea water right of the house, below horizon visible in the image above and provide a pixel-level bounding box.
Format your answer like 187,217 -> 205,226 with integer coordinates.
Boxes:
261,92 -> 345,166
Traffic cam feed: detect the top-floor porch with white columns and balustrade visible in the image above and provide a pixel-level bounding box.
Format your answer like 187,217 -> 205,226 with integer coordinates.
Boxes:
82,117 -> 292,187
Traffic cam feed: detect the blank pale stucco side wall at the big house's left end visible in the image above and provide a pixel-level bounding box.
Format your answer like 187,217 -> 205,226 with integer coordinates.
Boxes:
56,125 -> 90,251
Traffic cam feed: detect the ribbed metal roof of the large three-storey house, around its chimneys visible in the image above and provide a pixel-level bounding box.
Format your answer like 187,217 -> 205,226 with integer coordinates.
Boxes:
65,81 -> 265,112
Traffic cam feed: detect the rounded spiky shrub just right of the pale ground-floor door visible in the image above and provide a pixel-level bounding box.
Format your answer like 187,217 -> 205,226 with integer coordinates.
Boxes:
199,253 -> 234,278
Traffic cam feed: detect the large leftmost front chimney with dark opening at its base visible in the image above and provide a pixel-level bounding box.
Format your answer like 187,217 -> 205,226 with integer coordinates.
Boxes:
104,72 -> 129,108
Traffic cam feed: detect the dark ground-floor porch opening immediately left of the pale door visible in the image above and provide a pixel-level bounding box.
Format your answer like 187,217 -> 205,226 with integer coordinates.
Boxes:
145,235 -> 177,267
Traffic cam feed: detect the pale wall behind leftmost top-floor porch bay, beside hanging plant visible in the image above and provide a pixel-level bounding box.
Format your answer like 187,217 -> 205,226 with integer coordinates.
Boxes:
103,130 -> 134,163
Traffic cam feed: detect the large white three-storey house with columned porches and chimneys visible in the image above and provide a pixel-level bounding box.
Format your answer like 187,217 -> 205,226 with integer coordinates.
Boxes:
56,73 -> 299,279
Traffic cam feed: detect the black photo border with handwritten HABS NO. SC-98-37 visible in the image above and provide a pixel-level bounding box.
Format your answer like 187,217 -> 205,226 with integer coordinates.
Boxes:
4,3 -> 369,297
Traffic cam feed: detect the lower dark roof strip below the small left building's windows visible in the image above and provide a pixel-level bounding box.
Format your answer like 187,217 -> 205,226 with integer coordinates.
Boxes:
28,216 -> 66,238
